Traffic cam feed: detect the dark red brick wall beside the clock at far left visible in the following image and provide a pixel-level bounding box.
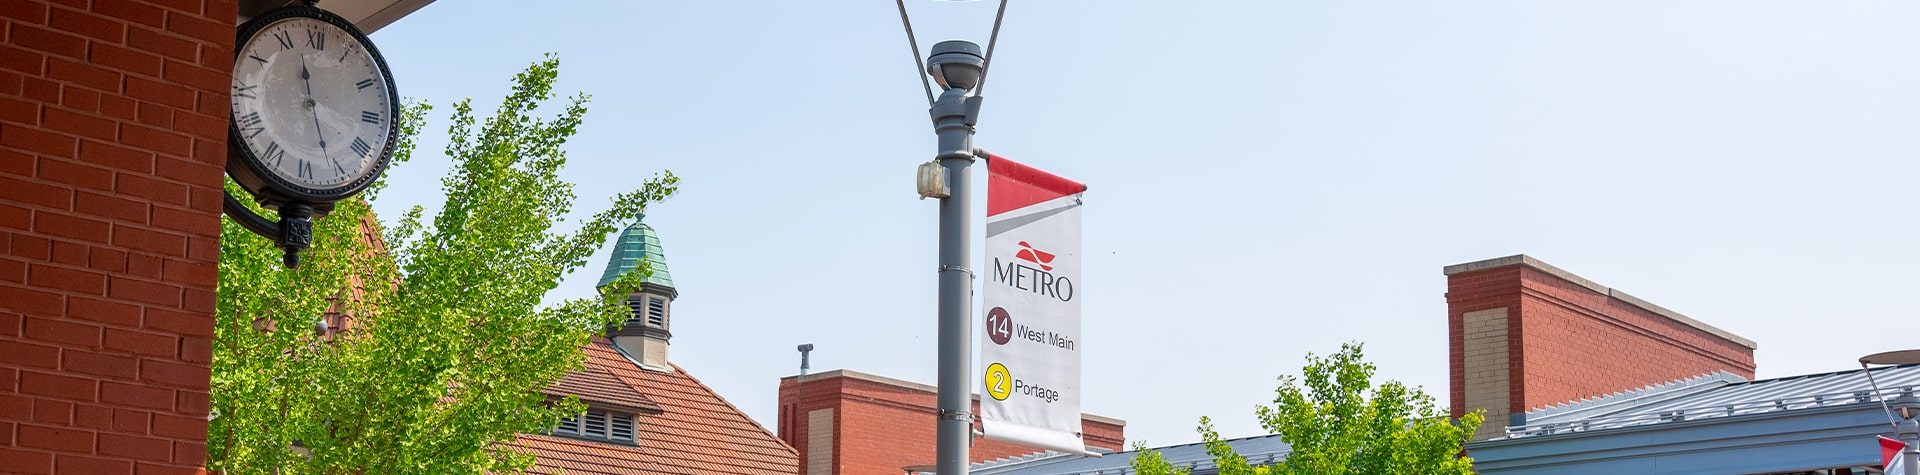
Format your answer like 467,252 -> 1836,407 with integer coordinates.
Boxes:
0,0 -> 236,473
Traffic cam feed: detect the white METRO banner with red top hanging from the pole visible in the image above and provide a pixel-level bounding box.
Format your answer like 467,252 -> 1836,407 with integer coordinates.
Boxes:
979,156 -> 1089,454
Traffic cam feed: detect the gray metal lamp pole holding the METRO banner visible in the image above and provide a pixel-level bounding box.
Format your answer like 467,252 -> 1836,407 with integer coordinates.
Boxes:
927,40 -> 987,475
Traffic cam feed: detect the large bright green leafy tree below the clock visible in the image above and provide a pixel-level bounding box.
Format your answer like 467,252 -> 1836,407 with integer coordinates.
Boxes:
207,56 -> 678,473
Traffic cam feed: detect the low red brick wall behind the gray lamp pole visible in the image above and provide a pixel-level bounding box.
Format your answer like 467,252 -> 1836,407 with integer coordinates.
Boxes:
780,377 -> 1125,475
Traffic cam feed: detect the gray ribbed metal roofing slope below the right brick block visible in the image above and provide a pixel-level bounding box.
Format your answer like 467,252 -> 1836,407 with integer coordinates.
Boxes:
1507,365 -> 1920,437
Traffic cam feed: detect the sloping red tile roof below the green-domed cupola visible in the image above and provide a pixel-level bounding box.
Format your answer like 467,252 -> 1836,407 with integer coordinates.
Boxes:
516,337 -> 799,475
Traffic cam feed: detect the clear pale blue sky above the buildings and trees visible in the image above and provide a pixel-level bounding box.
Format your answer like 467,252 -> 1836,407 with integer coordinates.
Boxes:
374,0 -> 1920,444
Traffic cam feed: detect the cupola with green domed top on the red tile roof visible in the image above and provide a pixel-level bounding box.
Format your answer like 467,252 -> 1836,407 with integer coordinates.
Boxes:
599,215 -> 680,371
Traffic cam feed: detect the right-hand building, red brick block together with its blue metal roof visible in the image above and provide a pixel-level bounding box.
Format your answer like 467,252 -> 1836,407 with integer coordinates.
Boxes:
1444,256 -> 1889,475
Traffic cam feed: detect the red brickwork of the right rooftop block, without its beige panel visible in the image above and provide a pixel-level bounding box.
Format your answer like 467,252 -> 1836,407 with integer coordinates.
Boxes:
1448,257 -> 1755,423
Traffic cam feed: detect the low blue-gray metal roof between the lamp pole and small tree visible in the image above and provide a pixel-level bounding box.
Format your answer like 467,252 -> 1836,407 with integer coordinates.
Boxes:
972,435 -> 1290,475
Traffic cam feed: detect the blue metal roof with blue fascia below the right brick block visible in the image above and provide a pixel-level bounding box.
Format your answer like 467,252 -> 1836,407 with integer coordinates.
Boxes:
1467,365 -> 1920,475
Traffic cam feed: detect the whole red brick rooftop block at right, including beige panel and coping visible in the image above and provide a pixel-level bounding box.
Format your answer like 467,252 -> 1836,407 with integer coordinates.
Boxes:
1444,254 -> 1755,440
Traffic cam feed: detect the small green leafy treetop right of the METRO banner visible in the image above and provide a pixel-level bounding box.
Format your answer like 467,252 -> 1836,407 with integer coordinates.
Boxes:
1133,342 -> 1484,475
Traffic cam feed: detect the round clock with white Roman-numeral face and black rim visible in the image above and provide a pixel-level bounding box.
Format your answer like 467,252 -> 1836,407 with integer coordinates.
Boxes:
232,15 -> 397,194
